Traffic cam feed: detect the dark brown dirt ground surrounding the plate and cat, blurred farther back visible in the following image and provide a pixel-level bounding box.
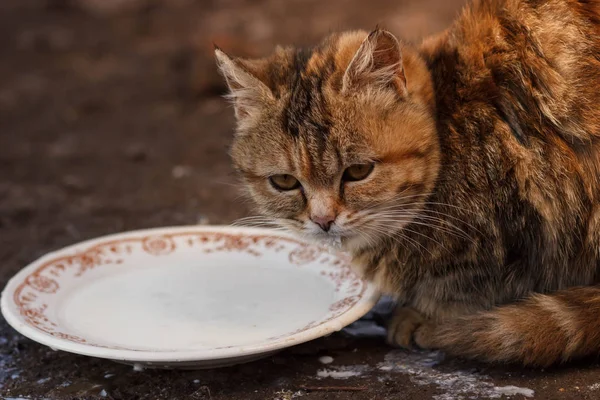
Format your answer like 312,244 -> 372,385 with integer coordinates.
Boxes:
0,0 -> 600,400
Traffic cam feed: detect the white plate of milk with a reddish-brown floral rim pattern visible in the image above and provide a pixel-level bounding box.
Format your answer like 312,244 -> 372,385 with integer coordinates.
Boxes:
1,226 -> 379,368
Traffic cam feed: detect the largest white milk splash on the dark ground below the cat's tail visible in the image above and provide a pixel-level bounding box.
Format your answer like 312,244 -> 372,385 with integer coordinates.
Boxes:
378,350 -> 534,400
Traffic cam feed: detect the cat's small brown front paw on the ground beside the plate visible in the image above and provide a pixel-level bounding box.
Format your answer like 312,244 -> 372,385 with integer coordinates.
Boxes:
387,307 -> 434,349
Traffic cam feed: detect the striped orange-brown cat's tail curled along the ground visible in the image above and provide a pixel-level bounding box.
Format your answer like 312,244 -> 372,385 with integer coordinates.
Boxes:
426,287 -> 600,367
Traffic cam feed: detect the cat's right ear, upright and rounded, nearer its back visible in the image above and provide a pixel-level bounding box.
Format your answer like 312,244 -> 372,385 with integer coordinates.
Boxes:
342,29 -> 407,96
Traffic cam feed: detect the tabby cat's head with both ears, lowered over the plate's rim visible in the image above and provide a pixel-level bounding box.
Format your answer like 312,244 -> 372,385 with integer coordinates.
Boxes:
216,30 -> 440,248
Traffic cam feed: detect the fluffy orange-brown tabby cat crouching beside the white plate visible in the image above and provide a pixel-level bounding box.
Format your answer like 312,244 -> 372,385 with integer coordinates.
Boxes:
215,0 -> 600,367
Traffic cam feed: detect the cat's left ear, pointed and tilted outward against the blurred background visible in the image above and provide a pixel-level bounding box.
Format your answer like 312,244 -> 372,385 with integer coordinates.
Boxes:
215,46 -> 273,121
